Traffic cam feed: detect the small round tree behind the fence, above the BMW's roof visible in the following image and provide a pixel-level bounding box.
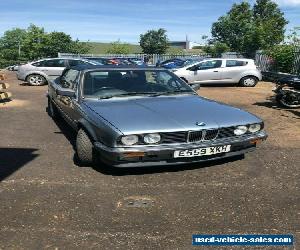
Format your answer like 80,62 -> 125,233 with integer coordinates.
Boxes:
140,29 -> 168,54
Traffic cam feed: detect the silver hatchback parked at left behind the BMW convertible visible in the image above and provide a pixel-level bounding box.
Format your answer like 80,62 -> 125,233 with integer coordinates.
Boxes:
17,58 -> 102,86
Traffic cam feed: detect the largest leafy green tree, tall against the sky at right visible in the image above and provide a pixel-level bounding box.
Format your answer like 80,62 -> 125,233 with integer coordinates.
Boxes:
212,0 -> 288,55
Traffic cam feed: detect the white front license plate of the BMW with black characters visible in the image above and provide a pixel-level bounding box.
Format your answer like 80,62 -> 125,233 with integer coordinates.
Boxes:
174,145 -> 231,158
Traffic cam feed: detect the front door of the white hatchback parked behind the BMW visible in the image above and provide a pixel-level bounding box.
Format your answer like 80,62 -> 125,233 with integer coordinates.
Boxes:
192,59 -> 222,83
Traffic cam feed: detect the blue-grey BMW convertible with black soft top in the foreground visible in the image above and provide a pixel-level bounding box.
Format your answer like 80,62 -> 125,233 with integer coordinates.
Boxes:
47,65 -> 267,167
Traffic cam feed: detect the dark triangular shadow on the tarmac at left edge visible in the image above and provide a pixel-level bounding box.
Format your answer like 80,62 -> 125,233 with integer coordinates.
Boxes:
0,148 -> 38,181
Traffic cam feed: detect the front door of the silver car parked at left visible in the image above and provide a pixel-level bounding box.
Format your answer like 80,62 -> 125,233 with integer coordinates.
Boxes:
40,58 -> 66,80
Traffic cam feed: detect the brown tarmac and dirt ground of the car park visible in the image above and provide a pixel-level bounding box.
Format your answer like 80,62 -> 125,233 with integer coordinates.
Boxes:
0,72 -> 300,249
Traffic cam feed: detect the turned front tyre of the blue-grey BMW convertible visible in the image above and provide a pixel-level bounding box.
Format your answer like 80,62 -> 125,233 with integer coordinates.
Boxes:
76,129 -> 94,165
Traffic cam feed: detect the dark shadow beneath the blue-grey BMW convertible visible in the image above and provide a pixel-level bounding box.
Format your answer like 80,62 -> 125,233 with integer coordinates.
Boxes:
49,111 -> 244,176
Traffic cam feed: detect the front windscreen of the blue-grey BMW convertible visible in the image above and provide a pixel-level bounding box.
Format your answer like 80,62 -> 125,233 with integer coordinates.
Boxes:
83,70 -> 194,99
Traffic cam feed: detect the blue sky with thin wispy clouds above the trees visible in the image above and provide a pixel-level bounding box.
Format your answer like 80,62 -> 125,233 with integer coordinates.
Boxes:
0,0 -> 300,44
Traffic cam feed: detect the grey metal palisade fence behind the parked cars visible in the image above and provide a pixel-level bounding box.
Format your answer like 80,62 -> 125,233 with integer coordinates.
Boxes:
58,52 -> 243,65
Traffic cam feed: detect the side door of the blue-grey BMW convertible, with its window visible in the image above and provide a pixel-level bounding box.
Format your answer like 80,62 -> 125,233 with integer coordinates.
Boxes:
57,69 -> 80,127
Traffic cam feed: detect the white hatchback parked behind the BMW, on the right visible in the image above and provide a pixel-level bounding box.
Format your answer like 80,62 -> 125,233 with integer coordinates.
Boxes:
173,58 -> 262,87
